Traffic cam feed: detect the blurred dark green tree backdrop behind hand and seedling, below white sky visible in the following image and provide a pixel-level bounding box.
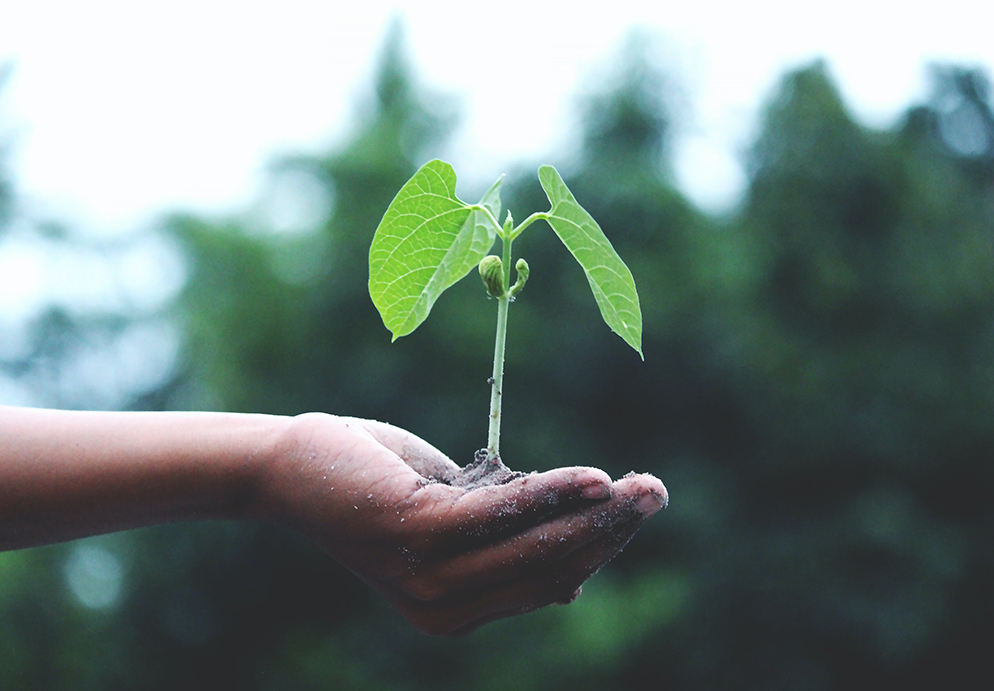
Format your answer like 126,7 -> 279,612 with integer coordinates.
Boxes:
0,5 -> 994,691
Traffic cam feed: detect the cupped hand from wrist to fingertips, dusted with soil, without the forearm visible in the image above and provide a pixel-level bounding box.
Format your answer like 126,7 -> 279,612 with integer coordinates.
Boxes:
266,414 -> 667,635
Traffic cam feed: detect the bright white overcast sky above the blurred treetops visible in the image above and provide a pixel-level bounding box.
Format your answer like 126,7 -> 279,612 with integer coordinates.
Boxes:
0,0 -> 994,232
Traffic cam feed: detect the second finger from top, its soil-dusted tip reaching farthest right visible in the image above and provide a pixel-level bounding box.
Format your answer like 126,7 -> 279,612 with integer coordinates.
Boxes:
404,477 -> 665,599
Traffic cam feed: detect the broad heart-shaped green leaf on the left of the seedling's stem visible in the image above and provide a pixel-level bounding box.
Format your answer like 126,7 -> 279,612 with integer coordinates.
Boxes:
369,160 -> 503,340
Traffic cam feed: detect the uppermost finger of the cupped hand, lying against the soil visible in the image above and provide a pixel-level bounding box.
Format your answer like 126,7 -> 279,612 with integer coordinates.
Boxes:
414,467 -> 612,558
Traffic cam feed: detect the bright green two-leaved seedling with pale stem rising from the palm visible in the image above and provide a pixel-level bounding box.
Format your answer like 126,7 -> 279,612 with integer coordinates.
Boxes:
369,160 -> 642,463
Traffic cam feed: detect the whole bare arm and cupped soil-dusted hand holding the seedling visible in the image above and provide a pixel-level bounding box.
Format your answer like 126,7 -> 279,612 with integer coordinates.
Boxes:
0,406 -> 667,635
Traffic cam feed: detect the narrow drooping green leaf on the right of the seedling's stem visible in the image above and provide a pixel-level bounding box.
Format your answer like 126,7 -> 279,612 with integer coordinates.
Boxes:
538,166 -> 645,360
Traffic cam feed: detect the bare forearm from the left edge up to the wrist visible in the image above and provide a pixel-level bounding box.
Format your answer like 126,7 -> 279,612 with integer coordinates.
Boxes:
0,406 -> 292,549
